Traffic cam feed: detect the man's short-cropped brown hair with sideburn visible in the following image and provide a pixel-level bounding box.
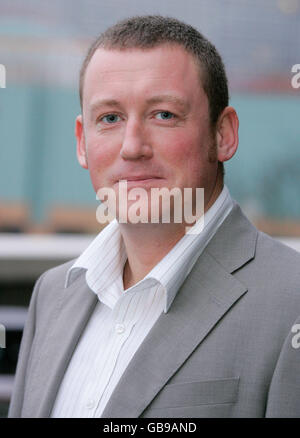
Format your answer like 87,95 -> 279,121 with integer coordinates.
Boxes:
79,15 -> 229,125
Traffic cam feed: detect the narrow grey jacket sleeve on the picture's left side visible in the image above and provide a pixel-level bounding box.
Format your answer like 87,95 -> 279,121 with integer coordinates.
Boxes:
8,273 -> 45,418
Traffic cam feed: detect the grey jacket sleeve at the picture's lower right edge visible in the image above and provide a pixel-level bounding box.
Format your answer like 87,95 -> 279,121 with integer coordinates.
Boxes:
265,317 -> 300,418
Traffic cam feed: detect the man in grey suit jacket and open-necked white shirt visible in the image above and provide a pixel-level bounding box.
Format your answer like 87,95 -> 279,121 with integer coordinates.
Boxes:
9,16 -> 300,418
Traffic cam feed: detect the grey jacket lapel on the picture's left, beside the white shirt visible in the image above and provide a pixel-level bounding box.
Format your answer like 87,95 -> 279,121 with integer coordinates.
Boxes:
23,274 -> 98,417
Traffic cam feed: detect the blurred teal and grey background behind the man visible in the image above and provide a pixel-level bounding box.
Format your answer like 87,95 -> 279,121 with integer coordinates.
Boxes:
0,0 -> 300,416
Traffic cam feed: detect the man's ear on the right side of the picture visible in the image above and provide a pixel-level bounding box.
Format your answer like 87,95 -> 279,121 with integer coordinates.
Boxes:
217,106 -> 239,162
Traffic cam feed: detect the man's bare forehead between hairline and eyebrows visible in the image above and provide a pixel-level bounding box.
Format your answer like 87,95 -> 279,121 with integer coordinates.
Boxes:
83,44 -> 203,108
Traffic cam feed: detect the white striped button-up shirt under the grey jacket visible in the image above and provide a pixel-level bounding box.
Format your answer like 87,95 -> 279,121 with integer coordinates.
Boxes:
51,186 -> 233,418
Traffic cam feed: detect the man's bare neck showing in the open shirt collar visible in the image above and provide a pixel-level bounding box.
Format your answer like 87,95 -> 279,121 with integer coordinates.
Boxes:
119,172 -> 223,290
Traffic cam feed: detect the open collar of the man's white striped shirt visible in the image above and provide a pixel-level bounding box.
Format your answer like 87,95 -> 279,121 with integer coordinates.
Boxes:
65,186 -> 233,312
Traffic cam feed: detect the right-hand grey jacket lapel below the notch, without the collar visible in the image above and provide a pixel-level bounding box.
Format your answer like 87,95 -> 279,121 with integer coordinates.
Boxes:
102,252 -> 246,418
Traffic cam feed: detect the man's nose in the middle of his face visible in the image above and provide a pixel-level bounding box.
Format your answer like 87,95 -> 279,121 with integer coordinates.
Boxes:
120,120 -> 153,160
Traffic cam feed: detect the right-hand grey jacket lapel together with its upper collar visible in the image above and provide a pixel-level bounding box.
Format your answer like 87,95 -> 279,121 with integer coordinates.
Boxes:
102,205 -> 257,418
